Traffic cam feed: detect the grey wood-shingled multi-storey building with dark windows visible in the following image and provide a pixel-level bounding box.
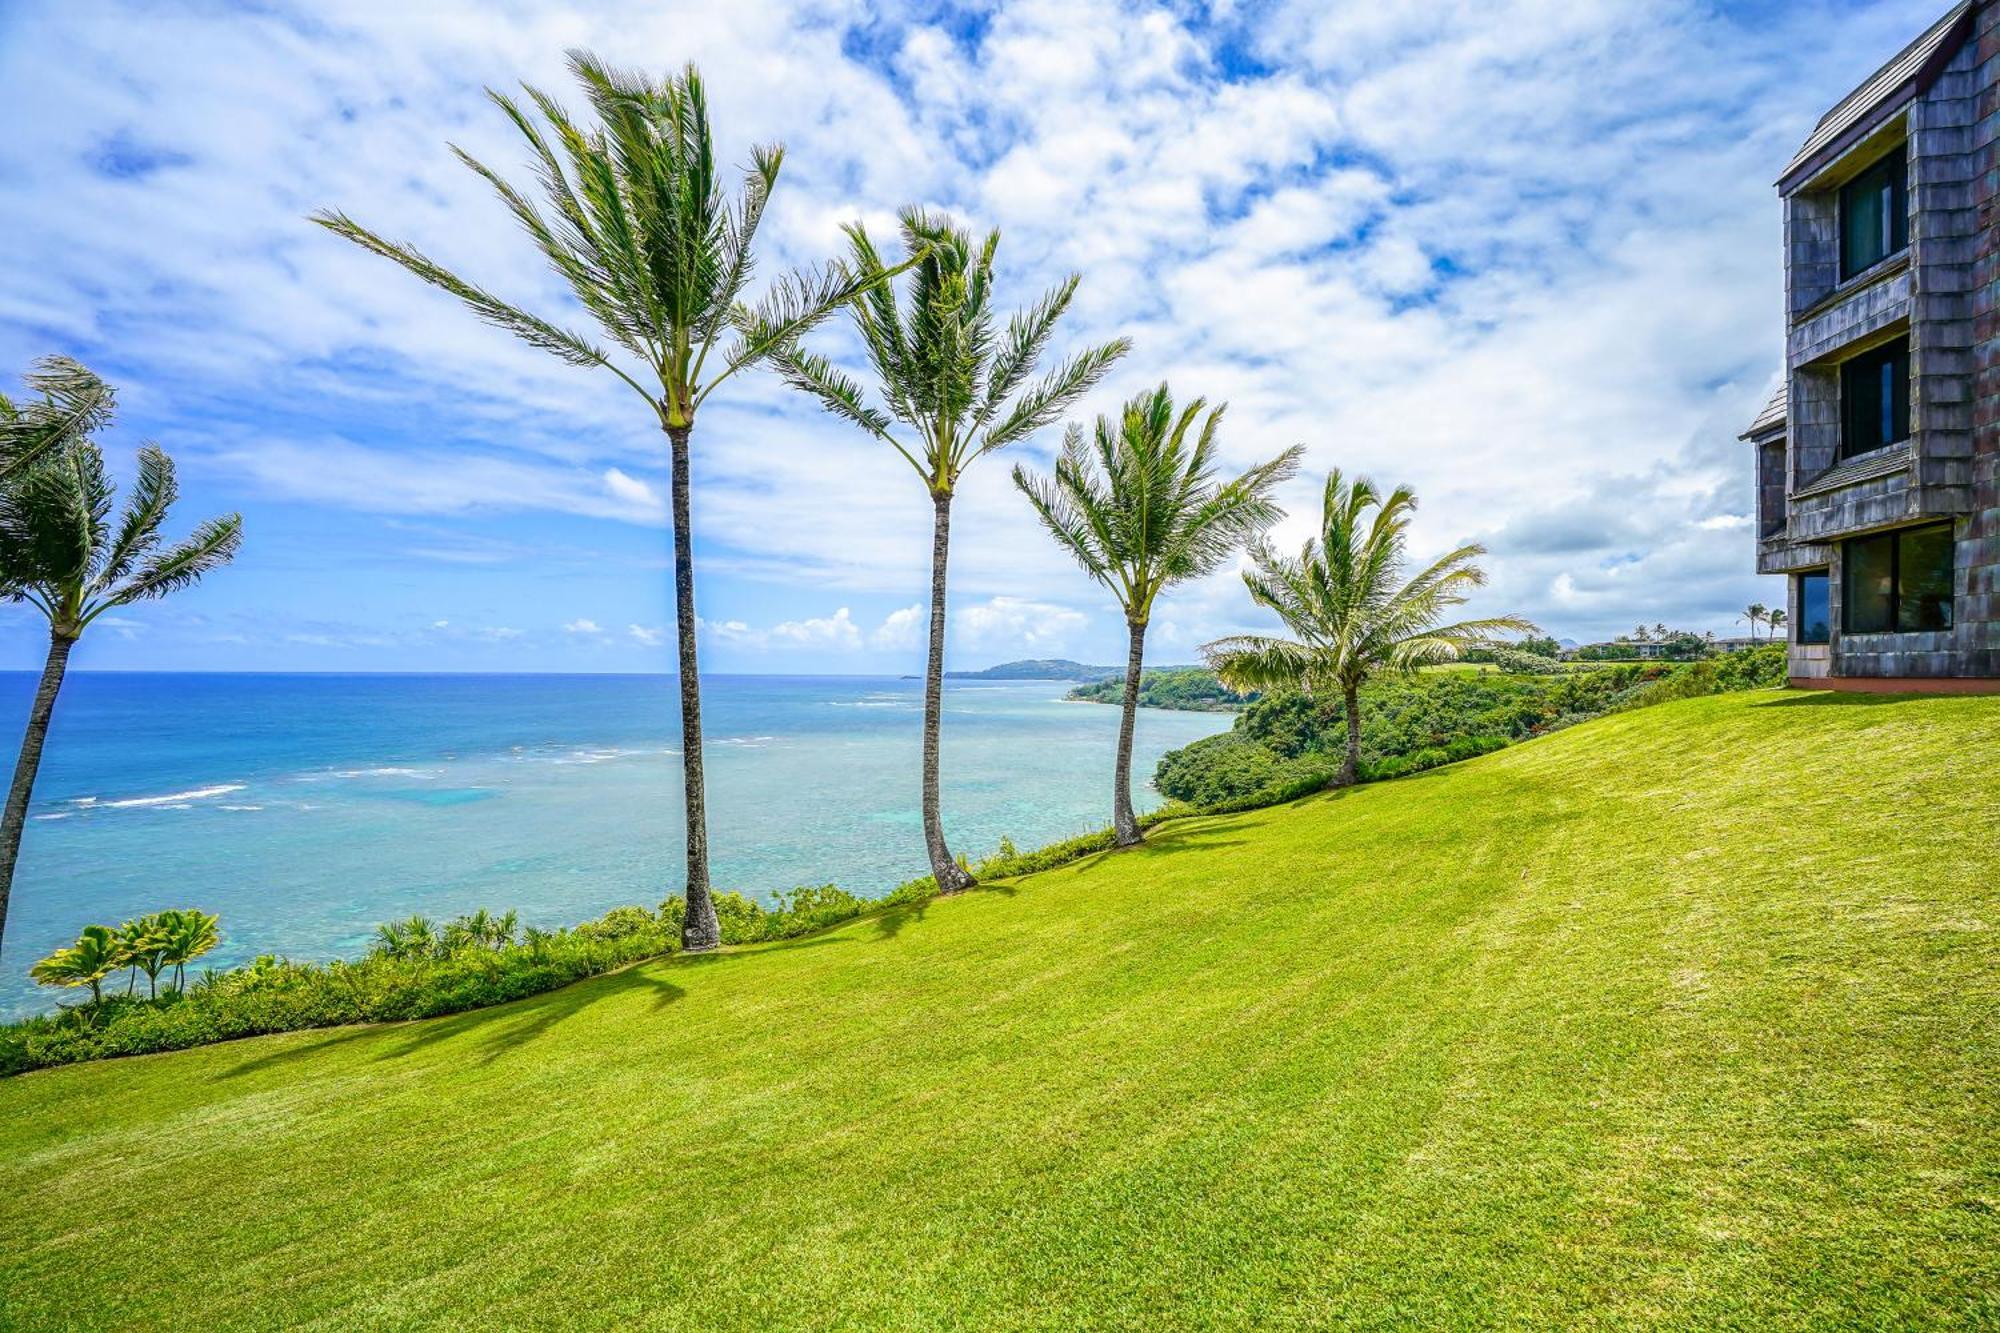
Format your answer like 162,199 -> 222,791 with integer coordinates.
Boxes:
1744,0 -> 2000,691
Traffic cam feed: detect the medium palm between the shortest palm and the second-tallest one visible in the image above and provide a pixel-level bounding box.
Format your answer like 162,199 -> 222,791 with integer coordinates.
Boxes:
1014,384 -> 1304,847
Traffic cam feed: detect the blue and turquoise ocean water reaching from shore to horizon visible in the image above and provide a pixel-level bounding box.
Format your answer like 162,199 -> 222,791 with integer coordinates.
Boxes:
0,673 -> 1228,1015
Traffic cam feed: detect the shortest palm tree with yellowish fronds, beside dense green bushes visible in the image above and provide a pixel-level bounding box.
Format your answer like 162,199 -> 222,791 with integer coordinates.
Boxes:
1202,468 -> 1536,787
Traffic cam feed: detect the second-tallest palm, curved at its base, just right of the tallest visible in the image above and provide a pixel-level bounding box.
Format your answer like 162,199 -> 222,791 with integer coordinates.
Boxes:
774,208 -> 1130,893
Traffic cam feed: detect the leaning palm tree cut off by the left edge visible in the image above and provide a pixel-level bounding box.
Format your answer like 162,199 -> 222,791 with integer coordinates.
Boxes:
0,422 -> 242,933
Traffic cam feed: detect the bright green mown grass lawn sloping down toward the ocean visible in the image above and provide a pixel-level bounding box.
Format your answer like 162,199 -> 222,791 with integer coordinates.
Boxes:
0,695 -> 2000,1327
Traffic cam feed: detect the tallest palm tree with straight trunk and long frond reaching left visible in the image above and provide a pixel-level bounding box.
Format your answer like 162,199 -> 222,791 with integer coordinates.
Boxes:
312,50 -> 866,953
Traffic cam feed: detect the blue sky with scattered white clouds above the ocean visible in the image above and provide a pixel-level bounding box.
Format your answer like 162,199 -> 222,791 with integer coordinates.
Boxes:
0,0 -> 1942,673
